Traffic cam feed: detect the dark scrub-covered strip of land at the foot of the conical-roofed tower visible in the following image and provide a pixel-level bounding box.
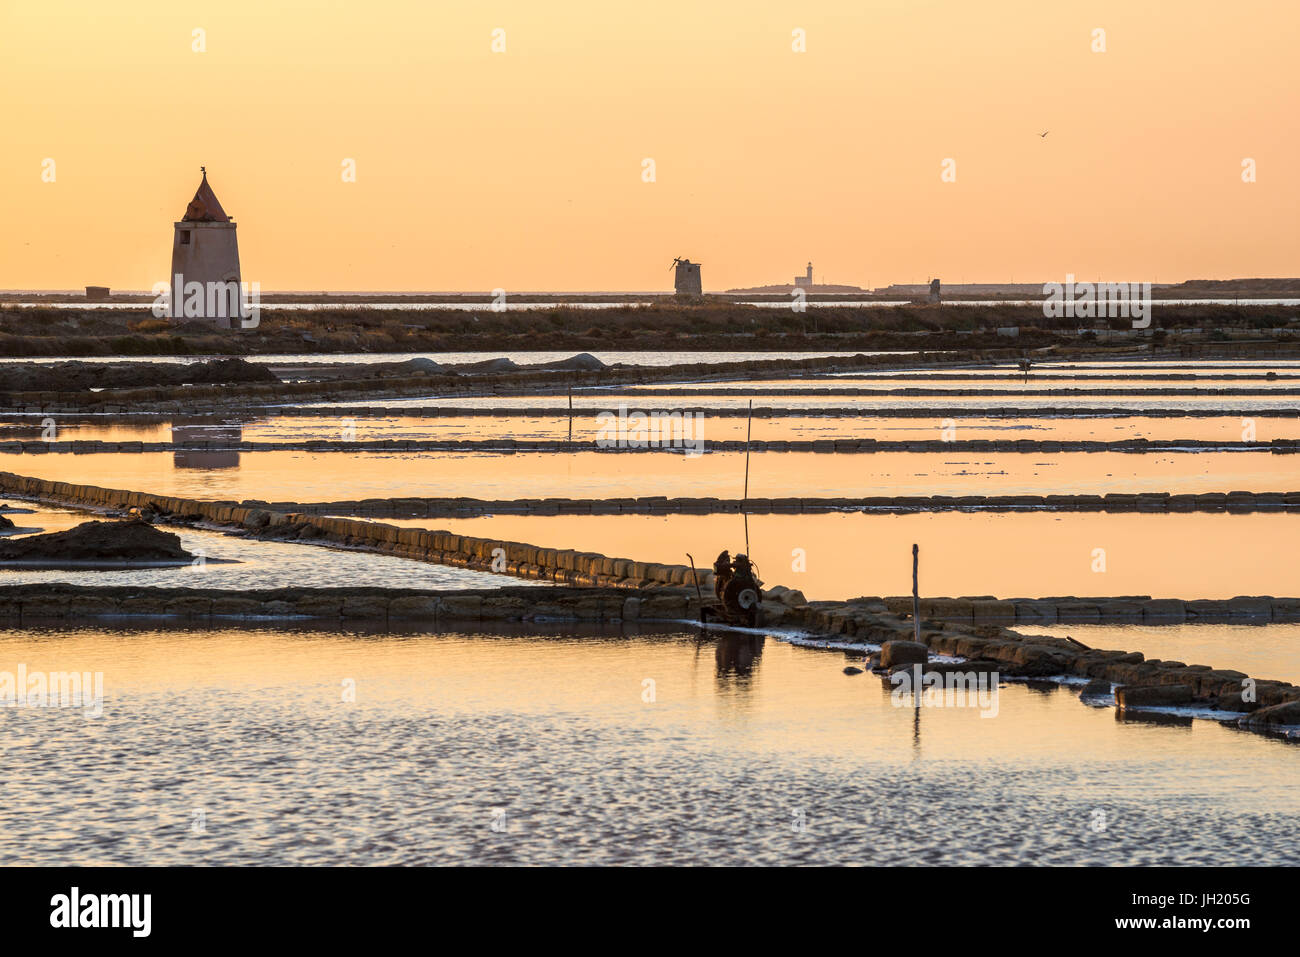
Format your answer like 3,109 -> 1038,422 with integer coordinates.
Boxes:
0,299 -> 1300,360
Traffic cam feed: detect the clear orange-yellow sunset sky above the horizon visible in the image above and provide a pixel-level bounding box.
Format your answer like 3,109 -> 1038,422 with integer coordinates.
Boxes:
0,0 -> 1300,291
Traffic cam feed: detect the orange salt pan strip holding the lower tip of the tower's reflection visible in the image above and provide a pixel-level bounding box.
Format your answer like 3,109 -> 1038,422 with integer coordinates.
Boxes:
10,447 -> 1300,502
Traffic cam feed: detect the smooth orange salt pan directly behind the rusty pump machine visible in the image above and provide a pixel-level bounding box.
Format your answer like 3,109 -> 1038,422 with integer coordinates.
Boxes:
400,511 -> 1300,600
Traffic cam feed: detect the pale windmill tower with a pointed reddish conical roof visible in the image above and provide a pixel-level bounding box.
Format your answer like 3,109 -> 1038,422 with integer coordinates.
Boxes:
172,166 -> 241,329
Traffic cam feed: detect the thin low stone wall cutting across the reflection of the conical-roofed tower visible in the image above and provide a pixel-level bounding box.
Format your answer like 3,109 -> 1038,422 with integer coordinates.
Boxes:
0,439 -> 1300,455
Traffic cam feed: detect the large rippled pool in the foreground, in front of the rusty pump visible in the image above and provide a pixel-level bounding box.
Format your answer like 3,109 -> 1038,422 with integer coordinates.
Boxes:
0,629 -> 1300,866
